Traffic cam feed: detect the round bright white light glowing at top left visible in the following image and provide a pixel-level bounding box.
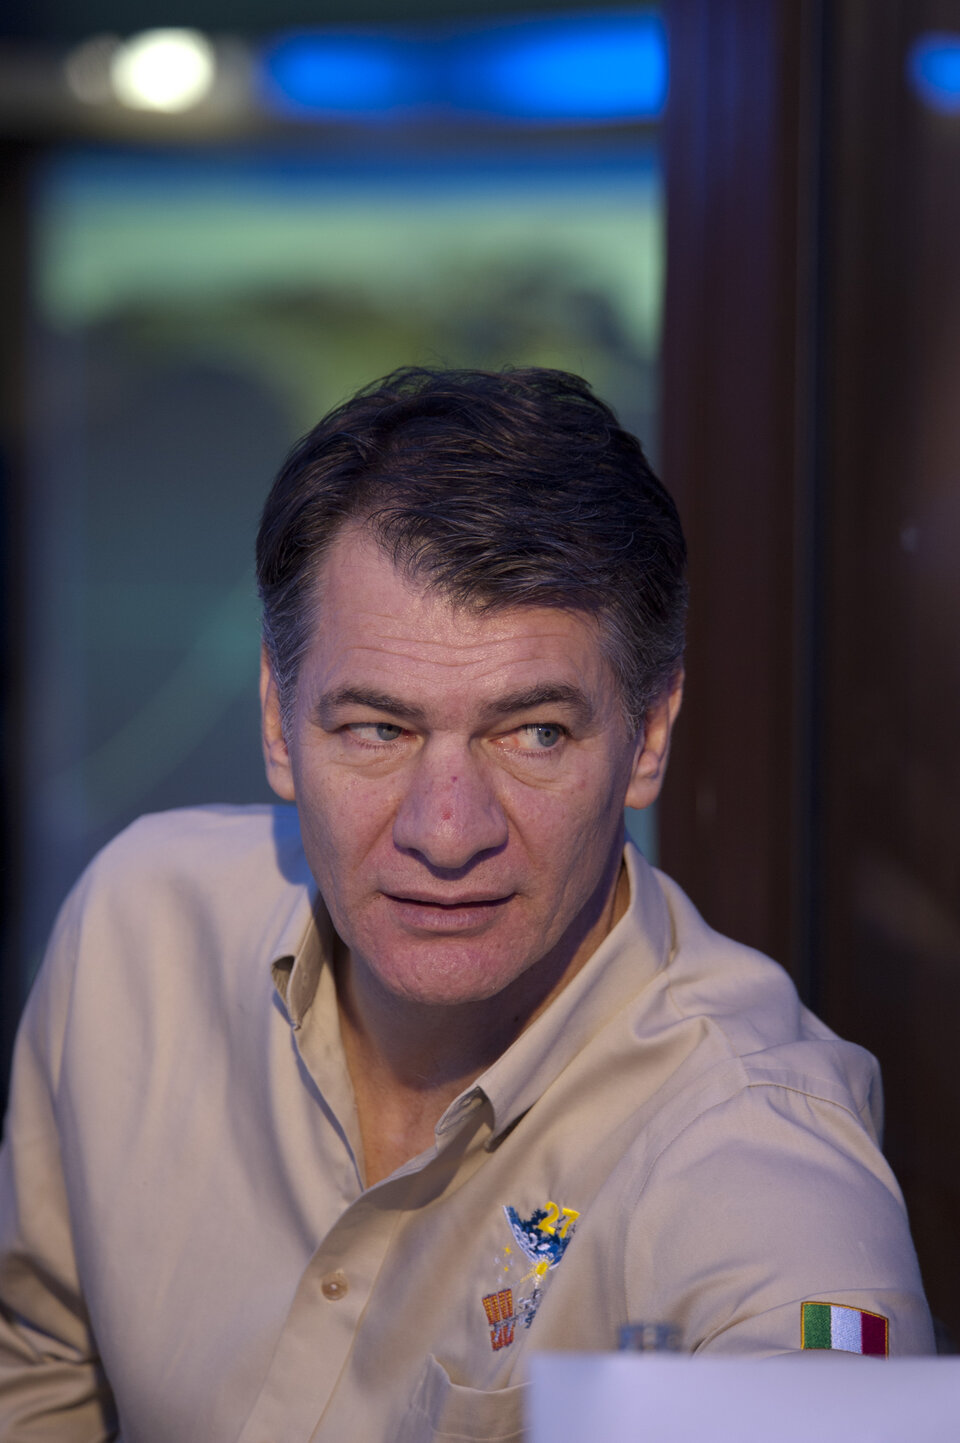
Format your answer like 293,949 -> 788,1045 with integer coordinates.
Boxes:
110,30 -> 217,111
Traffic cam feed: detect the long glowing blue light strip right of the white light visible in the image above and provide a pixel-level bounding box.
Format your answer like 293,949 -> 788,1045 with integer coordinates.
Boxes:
260,10 -> 667,124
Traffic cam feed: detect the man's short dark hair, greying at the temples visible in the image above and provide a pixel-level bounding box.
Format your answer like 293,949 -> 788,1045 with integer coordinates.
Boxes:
257,367 -> 686,727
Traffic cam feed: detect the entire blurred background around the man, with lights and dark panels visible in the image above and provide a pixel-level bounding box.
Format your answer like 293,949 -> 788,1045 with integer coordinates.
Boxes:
0,0 -> 960,1349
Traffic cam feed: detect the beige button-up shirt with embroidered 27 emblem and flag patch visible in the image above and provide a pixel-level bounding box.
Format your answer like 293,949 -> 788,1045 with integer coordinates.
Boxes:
0,807 -> 933,1443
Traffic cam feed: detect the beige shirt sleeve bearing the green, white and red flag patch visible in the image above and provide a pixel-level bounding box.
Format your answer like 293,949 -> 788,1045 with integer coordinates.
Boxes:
625,1084 -> 934,1355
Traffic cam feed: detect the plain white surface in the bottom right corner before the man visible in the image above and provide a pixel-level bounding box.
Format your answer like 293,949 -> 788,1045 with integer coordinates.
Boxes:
527,1352 -> 960,1443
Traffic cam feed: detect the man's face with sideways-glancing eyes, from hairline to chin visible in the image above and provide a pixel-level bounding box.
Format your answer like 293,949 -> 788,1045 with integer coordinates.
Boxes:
264,530 -> 668,1004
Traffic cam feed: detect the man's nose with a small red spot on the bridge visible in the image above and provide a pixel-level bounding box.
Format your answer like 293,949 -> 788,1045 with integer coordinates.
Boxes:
393,742 -> 508,872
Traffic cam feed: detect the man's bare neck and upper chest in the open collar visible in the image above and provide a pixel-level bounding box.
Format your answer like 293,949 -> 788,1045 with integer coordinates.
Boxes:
336,857 -> 629,1186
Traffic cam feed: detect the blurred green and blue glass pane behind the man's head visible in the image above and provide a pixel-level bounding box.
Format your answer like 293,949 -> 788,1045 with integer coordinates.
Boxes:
26,139 -> 663,961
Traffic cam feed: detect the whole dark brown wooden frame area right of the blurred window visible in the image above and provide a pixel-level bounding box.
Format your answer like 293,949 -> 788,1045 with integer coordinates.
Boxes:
661,0 -> 960,1349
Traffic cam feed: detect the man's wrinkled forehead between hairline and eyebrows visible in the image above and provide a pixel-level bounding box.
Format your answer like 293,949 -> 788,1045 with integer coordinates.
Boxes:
302,530 -> 612,700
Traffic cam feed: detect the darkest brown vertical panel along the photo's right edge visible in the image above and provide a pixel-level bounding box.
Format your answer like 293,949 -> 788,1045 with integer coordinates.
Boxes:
820,0 -> 960,1339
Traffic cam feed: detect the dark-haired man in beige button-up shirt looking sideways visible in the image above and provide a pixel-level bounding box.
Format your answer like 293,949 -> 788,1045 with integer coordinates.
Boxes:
0,369 -> 931,1443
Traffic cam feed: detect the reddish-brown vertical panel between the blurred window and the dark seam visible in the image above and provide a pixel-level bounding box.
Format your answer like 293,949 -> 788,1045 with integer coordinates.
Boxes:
661,0 -> 816,973
